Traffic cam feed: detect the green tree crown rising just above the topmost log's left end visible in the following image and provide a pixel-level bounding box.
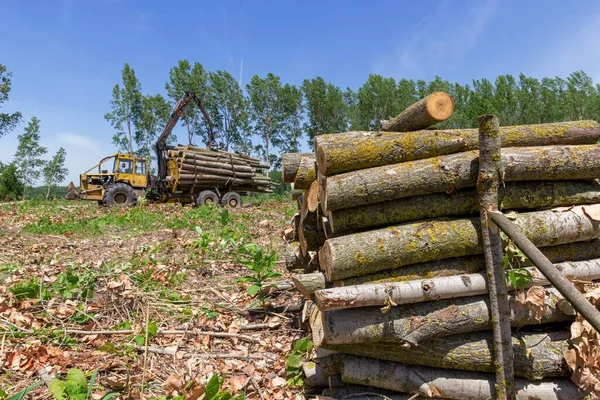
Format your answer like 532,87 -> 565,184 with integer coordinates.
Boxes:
358,74 -> 400,130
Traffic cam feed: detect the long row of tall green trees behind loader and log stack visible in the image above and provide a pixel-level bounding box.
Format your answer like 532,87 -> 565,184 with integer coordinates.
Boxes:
105,60 -> 600,166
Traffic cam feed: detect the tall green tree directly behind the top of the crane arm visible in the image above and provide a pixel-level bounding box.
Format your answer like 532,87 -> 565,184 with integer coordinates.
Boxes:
165,60 -> 210,144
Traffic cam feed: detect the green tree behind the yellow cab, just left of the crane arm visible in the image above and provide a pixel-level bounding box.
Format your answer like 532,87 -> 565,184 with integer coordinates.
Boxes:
135,94 -> 174,169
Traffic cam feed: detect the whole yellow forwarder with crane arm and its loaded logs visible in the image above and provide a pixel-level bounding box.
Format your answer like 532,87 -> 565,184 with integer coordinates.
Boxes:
67,92 -> 274,207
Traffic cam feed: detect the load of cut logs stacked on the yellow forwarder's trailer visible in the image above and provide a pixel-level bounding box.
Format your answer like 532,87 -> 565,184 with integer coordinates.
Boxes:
168,145 -> 275,193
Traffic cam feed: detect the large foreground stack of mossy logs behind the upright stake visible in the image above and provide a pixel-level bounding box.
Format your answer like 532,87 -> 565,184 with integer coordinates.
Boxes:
284,92 -> 600,399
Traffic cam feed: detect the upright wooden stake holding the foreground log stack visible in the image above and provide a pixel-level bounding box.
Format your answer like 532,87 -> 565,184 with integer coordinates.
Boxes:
477,115 -> 516,400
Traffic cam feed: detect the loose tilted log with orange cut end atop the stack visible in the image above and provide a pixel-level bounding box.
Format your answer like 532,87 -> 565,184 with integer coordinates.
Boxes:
381,92 -> 454,132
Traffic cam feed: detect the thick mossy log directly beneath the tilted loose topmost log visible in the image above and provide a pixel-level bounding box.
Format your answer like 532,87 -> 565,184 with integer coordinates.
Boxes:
315,121 -> 600,176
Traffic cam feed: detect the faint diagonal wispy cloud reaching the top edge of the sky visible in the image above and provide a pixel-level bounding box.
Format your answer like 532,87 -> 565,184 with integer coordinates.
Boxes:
374,0 -> 497,78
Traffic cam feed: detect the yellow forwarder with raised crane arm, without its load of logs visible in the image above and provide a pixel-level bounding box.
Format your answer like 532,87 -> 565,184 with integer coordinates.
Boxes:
66,92 -> 270,207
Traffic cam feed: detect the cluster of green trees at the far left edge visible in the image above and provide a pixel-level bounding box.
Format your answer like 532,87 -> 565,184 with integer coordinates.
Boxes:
0,64 -> 68,201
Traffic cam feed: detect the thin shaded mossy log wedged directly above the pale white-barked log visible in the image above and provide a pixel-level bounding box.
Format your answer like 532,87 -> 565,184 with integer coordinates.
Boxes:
332,239 -> 600,287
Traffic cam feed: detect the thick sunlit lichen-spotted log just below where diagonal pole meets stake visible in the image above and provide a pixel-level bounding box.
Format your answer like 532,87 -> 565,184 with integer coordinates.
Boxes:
319,205 -> 600,281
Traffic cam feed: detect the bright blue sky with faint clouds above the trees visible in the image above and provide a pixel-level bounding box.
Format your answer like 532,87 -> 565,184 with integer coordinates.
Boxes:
0,0 -> 600,182
